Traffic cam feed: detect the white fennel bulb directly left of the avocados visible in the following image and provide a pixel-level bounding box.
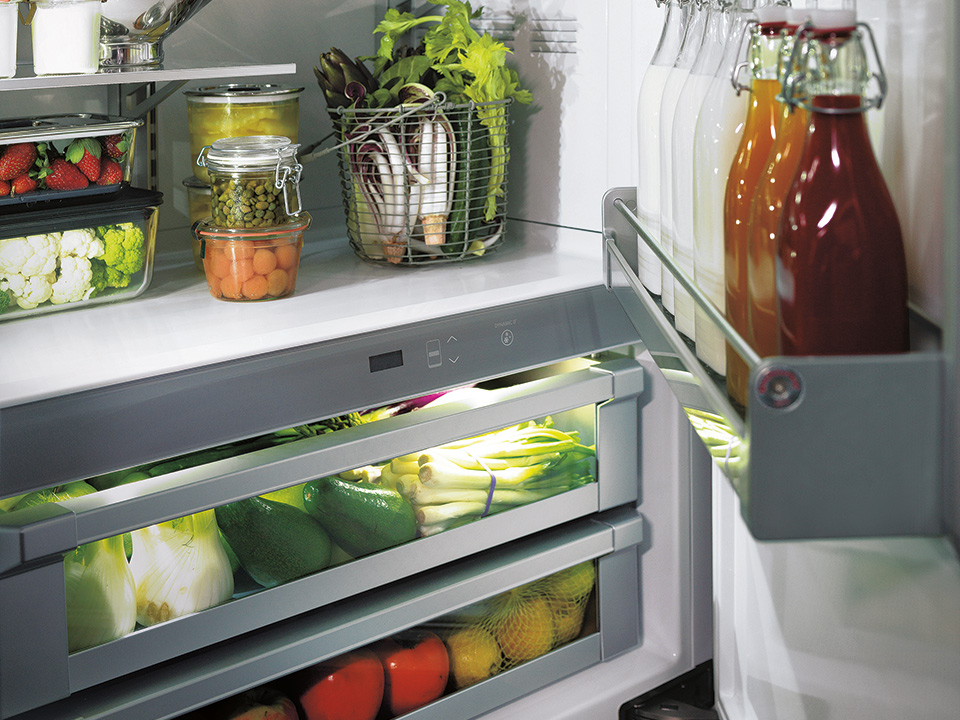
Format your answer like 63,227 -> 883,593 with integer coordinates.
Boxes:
130,510 -> 233,626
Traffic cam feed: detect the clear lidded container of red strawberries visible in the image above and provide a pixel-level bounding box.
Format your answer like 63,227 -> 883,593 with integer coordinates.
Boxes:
0,113 -> 143,207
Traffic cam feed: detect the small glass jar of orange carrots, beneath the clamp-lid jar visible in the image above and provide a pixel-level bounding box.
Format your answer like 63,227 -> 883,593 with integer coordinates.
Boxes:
194,213 -> 310,301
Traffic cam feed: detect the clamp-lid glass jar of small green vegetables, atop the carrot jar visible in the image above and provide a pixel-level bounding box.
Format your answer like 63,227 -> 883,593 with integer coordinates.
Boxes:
197,135 -> 302,228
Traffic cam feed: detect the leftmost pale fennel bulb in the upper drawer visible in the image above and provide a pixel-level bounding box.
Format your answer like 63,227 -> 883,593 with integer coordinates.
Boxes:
63,535 -> 137,652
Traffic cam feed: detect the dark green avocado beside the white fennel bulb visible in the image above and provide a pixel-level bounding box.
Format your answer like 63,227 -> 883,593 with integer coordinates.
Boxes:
216,497 -> 330,588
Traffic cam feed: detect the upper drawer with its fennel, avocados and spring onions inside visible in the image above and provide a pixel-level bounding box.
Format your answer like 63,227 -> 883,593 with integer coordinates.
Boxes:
0,353 -> 644,717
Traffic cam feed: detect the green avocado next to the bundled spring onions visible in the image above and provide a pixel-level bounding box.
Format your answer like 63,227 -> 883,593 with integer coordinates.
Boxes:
303,476 -> 417,557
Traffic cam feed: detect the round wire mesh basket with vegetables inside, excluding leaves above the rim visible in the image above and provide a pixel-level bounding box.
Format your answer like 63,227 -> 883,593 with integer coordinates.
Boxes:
331,93 -> 511,265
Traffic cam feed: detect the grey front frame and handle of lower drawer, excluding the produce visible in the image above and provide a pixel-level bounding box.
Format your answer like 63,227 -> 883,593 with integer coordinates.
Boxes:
11,507 -> 644,720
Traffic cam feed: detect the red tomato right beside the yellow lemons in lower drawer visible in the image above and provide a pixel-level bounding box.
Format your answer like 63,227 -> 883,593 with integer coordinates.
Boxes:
373,629 -> 450,715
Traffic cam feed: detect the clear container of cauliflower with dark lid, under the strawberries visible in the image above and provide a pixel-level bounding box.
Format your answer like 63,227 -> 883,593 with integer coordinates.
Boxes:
0,187 -> 163,321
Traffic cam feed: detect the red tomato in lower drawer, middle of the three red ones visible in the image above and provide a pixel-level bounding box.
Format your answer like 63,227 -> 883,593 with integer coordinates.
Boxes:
297,649 -> 383,720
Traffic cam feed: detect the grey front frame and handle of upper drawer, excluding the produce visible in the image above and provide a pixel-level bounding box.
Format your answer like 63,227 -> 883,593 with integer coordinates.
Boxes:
0,358 -> 643,718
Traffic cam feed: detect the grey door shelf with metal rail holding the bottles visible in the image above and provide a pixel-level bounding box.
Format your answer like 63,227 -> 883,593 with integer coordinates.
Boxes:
603,188 -> 944,540
